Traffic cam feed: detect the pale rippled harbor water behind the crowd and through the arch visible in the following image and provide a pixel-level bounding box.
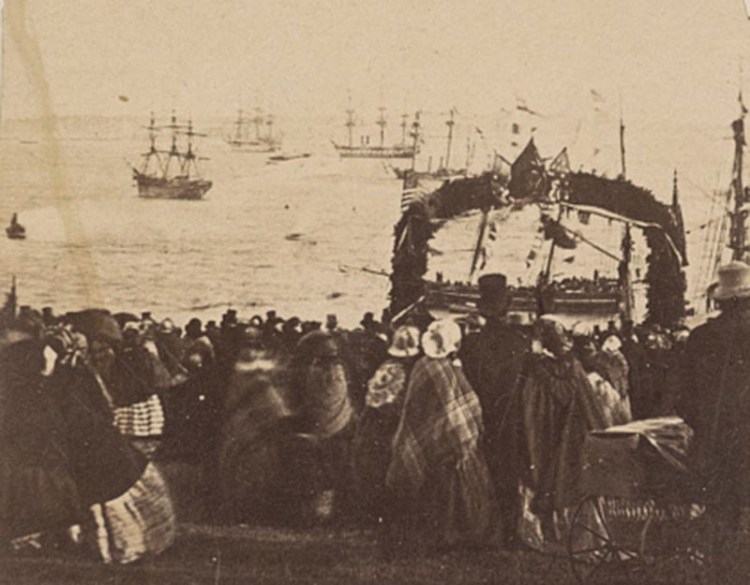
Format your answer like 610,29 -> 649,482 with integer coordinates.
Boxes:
0,117 -> 736,326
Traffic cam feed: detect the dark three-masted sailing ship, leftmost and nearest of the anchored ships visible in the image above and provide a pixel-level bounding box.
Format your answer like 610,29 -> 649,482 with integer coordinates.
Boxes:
133,113 -> 213,200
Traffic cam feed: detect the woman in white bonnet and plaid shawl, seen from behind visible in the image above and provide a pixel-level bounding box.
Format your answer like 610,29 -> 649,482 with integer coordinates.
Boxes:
379,320 -> 499,557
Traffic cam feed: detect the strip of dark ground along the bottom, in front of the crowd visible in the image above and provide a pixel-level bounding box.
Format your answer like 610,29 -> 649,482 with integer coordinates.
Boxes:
0,525 -> 696,585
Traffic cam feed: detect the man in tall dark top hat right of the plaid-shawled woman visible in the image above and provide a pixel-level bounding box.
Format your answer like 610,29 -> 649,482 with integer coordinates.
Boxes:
460,274 -> 531,547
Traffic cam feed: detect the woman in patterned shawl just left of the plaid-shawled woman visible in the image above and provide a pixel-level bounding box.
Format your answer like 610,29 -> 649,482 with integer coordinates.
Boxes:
352,325 -> 421,522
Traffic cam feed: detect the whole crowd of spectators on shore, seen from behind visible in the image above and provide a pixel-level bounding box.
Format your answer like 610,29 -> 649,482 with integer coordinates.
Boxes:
0,263 -> 750,580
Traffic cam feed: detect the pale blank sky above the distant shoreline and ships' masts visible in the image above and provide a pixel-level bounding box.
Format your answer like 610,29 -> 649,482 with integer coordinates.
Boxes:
2,0 -> 750,124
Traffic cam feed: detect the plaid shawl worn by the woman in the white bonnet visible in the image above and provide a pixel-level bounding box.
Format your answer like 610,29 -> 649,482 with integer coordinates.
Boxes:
386,357 -> 483,495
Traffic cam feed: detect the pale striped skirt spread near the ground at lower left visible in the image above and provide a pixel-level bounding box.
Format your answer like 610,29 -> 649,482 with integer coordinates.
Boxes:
83,463 -> 176,564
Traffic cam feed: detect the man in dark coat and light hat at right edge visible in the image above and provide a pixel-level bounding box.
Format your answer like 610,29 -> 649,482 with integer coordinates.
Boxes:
676,262 -> 750,584
